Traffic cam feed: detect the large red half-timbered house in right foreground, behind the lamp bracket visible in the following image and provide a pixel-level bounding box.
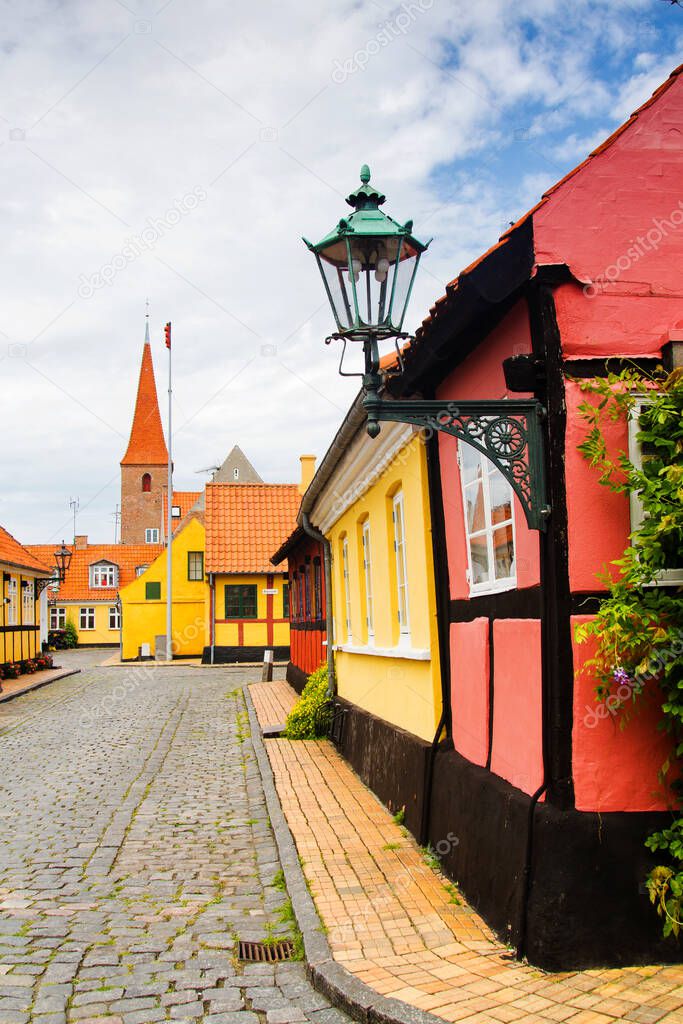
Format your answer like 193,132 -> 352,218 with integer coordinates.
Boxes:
391,69 -> 683,968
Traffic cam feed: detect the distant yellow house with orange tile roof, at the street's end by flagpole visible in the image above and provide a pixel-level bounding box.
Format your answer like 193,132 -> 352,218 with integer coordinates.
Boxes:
120,483 -> 301,664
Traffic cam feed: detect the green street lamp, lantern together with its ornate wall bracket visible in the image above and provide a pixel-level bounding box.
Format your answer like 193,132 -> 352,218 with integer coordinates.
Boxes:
303,164 -> 550,530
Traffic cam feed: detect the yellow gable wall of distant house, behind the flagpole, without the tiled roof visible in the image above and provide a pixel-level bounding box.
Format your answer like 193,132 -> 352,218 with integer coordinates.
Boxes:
119,513 -> 209,660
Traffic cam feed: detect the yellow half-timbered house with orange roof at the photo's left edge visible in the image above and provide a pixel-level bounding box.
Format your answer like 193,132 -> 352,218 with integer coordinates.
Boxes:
0,526 -> 53,665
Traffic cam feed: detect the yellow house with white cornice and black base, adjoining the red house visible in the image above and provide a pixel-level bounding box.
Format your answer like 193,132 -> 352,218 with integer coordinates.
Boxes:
299,391 -> 443,833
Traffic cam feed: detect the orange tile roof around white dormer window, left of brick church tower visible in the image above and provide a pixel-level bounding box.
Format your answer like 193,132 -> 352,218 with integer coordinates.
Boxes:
29,544 -> 164,601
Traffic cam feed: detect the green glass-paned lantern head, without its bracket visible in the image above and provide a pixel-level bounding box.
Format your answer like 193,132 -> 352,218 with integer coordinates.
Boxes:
303,164 -> 431,342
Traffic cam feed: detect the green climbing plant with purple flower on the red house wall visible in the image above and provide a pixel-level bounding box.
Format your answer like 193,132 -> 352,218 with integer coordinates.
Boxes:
577,369 -> 683,937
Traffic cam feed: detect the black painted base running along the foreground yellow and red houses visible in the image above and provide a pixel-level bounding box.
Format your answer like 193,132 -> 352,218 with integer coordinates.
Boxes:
340,701 -> 683,970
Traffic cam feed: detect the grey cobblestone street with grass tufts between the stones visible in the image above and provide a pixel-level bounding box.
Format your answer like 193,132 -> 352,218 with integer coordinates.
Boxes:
0,651 -> 348,1024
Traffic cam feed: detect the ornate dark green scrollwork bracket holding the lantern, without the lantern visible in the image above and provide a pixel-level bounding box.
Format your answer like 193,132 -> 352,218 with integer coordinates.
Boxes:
362,342 -> 550,531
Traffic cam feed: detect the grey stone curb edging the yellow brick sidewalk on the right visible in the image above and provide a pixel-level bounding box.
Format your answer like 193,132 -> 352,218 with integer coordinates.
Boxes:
244,684 -> 443,1024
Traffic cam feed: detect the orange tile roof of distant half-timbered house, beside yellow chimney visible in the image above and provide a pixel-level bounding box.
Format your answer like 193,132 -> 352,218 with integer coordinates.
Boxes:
206,483 -> 301,572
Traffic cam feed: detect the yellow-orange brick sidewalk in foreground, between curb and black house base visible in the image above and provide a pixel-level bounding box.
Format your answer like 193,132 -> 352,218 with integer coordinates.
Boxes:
251,687 -> 683,1024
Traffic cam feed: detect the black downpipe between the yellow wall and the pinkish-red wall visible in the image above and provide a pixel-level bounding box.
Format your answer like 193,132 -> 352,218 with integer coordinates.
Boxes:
420,431 -> 452,846
